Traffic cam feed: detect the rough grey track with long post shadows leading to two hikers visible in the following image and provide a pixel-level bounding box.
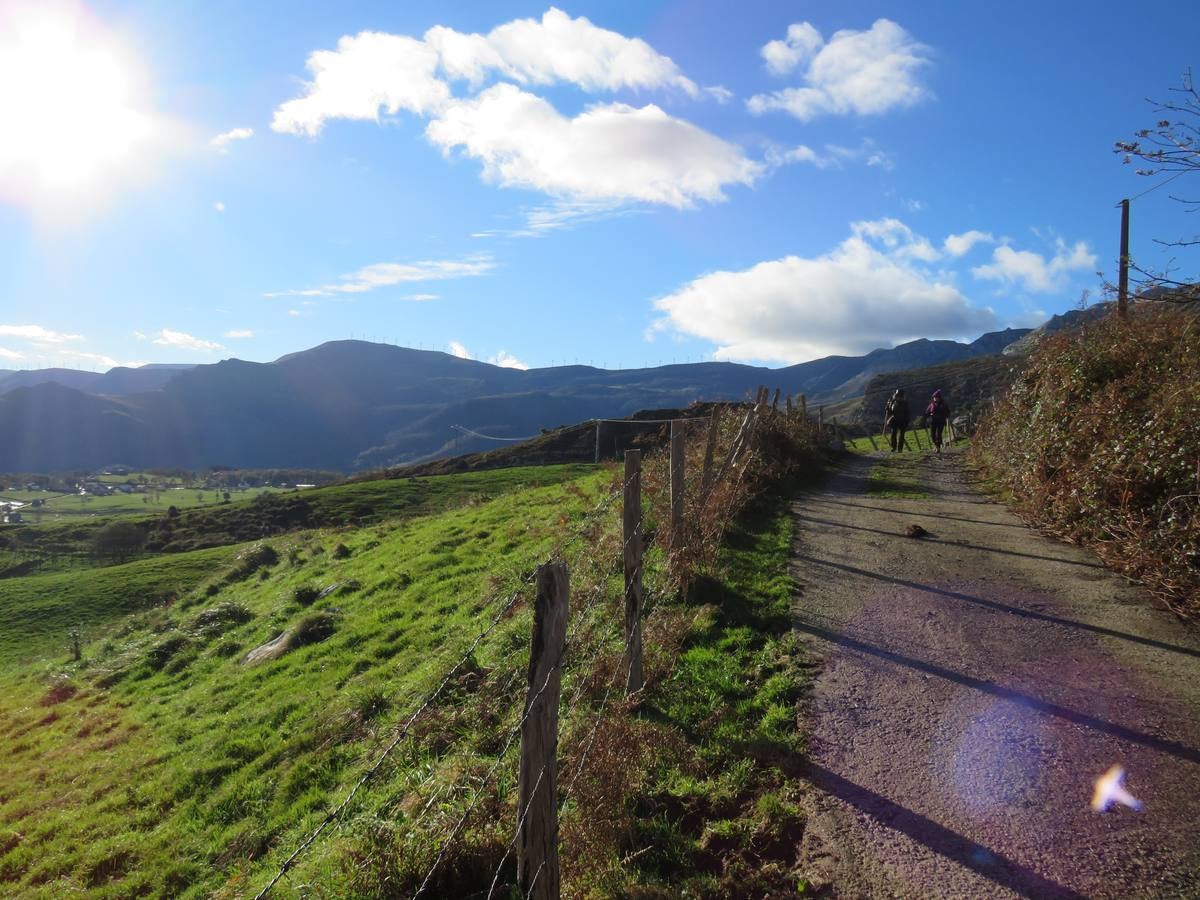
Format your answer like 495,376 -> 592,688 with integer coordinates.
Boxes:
793,455 -> 1200,898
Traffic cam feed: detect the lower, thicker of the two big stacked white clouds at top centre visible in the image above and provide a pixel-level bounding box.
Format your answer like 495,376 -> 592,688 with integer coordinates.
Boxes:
426,84 -> 766,208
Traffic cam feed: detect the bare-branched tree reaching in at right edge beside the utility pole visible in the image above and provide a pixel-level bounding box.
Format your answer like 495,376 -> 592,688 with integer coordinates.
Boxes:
1114,70 -> 1200,302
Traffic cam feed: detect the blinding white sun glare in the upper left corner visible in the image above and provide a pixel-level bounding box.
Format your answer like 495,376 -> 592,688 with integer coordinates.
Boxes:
0,4 -> 155,199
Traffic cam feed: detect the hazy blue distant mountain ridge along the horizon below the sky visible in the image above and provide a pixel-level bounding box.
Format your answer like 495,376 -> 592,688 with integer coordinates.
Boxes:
0,329 -> 1027,472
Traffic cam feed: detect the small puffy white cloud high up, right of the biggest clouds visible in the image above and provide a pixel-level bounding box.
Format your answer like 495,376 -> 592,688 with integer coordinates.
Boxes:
746,19 -> 931,121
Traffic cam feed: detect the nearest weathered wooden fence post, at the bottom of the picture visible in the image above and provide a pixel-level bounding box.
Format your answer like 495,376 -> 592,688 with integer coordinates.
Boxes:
517,563 -> 570,900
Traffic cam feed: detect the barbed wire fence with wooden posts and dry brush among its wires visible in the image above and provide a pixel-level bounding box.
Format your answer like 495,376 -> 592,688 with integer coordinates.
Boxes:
254,388 -> 809,900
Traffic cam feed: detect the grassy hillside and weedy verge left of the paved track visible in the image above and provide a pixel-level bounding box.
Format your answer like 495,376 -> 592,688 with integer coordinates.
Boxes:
0,416 -> 820,898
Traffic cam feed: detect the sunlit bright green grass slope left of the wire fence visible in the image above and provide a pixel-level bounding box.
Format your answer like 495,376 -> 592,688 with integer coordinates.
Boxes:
0,467 -> 607,898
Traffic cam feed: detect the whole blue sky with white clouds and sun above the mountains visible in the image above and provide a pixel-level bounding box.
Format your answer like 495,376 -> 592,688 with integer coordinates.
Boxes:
0,0 -> 1200,370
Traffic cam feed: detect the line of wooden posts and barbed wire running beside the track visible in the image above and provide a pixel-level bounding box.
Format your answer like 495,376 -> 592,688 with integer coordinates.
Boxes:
256,386 -> 824,900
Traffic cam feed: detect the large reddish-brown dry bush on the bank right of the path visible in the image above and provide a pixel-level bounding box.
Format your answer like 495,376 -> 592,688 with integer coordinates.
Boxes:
973,307 -> 1200,617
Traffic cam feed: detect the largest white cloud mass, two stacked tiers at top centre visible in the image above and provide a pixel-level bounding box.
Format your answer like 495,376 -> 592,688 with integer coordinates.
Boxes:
271,7 -> 744,208
